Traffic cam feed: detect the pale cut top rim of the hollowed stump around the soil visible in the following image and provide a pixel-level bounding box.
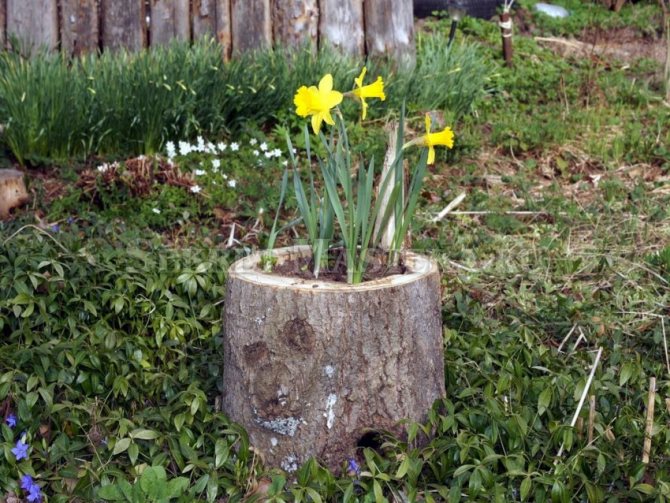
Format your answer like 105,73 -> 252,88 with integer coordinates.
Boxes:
228,246 -> 438,293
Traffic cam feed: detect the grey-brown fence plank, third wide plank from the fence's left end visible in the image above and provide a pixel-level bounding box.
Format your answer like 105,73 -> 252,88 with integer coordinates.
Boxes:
101,0 -> 147,51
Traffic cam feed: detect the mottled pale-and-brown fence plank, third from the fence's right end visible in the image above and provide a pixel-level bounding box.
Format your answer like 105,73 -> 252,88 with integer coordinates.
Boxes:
272,0 -> 319,49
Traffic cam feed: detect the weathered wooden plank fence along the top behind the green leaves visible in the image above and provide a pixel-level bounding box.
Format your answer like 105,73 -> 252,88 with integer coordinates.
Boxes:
0,0 -> 414,59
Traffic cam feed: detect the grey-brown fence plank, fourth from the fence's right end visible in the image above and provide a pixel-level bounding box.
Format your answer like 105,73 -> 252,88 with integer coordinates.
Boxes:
231,0 -> 272,52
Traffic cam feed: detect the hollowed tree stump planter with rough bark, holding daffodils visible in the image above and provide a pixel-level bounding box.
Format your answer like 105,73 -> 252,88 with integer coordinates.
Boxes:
223,247 -> 445,471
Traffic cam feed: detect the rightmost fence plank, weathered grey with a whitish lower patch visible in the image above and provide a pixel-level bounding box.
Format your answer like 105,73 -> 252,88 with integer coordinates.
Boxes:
365,0 -> 414,64
